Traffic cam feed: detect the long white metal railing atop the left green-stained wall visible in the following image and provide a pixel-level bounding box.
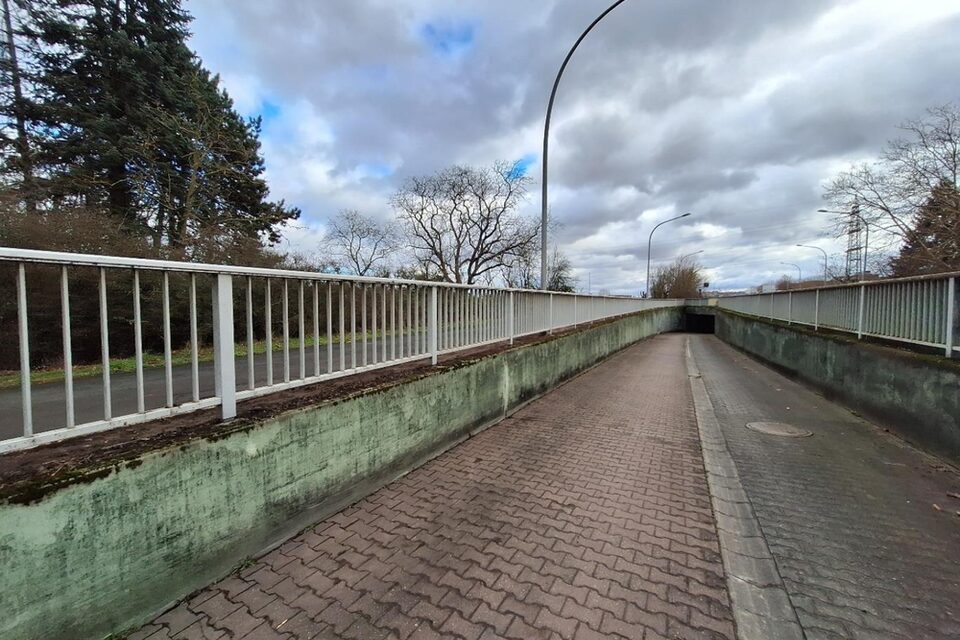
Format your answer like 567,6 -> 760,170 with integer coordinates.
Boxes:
0,247 -> 684,452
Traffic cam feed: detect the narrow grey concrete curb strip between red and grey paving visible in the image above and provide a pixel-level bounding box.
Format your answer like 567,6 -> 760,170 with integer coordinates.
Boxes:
686,338 -> 804,640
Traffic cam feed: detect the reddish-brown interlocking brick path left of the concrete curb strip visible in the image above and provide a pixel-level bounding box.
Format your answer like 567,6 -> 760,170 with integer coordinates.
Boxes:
130,335 -> 734,640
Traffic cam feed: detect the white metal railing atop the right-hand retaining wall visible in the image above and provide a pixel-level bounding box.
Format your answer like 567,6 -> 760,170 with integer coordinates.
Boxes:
718,273 -> 960,357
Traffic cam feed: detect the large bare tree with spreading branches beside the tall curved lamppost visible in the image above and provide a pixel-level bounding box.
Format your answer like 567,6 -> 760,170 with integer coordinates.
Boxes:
392,163 -> 540,284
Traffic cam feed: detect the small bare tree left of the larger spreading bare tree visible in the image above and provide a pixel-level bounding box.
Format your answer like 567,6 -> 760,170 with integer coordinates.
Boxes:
326,209 -> 398,276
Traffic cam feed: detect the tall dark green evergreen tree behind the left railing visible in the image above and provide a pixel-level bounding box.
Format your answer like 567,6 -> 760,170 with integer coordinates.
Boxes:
7,0 -> 299,259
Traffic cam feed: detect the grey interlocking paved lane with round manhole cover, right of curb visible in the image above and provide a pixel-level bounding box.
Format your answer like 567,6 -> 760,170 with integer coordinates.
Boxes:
690,336 -> 960,640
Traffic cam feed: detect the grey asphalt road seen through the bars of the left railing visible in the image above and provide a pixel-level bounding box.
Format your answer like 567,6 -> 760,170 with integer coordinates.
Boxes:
0,336 -> 424,440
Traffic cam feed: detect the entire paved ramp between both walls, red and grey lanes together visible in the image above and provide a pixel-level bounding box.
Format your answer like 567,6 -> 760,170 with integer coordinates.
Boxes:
129,334 -> 960,640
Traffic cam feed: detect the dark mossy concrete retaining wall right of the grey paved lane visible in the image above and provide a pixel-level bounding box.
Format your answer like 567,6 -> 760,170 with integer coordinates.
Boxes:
716,311 -> 960,464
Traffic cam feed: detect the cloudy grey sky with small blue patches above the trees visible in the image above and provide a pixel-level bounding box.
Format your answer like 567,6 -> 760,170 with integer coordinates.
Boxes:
185,0 -> 960,294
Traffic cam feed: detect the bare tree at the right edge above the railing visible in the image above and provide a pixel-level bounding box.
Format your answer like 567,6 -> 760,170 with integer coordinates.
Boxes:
824,104 -> 960,268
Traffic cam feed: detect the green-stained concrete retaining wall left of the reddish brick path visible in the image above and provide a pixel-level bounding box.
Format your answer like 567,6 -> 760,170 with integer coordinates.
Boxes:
0,308 -> 682,640
